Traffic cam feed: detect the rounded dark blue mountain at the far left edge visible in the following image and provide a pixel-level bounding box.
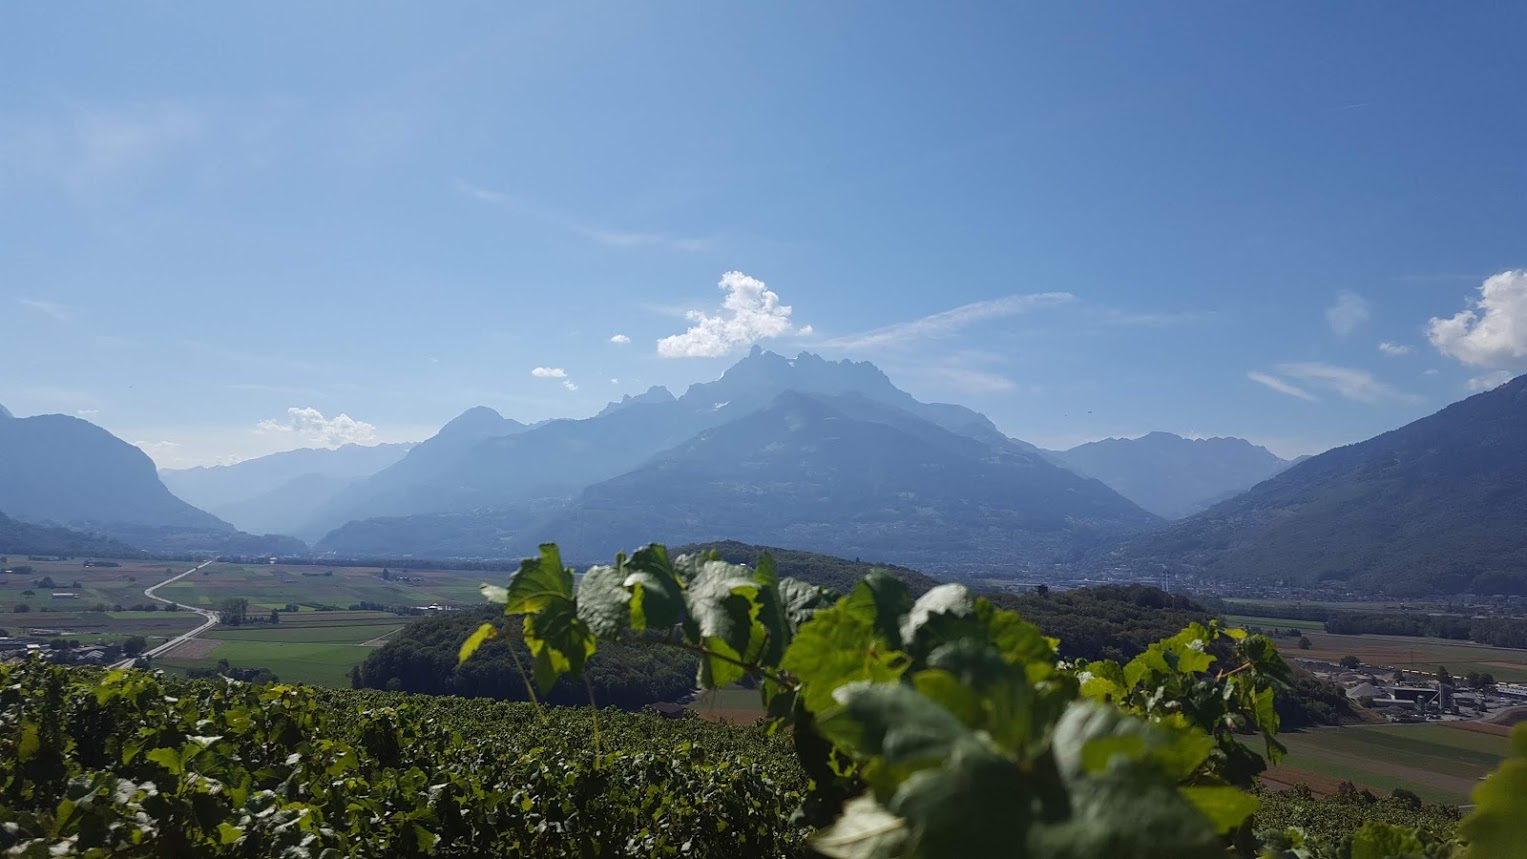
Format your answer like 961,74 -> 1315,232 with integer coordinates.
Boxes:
0,415 -> 305,554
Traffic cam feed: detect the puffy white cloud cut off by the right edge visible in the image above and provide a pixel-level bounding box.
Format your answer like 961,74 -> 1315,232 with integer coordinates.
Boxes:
1426,270 -> 1527,369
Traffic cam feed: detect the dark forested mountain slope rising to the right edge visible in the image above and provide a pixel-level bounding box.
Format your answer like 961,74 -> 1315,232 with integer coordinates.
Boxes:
1109,375 -> 1527,595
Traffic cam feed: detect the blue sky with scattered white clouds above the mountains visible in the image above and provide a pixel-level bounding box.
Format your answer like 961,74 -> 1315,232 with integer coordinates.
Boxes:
0,2 -> 1527,467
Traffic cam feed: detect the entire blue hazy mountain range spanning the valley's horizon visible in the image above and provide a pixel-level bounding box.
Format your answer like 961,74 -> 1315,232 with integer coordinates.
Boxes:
0,360 -> 1527,595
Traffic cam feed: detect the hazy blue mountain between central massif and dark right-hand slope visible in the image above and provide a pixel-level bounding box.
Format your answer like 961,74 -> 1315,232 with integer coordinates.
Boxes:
1049,432 -> 1289,519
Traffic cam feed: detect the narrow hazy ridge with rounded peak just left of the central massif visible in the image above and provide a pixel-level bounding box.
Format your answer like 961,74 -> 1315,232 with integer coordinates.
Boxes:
295,406 -> 530,539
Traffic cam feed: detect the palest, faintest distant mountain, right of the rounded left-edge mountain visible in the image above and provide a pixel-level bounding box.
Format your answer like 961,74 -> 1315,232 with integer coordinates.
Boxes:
159,444 -> 411,515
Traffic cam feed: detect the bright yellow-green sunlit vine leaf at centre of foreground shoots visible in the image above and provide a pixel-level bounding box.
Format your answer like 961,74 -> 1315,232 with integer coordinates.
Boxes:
780,598 -> 909,713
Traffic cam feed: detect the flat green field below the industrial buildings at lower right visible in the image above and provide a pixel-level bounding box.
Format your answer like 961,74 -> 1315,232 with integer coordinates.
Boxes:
1263,723 -> 1507,804
